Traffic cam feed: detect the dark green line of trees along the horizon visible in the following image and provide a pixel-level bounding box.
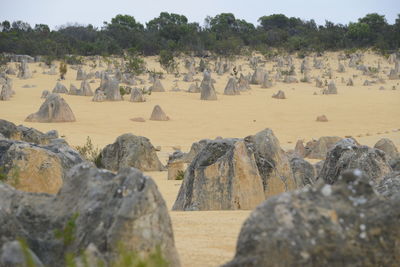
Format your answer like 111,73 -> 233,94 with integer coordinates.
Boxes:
0,12 -> 400,58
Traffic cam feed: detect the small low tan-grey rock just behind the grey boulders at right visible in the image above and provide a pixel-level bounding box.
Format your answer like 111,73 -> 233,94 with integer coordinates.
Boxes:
305,136 -> 342,159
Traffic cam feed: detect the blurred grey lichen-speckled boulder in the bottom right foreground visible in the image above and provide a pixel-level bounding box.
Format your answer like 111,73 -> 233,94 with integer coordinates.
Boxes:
223,171 -> 400,267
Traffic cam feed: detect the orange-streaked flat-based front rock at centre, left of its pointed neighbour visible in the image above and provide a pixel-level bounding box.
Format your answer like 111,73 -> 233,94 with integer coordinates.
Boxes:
172,139 -> 265,210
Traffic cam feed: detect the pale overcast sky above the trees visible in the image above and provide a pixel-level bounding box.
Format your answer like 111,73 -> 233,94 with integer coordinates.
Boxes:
0,0 -> 400,28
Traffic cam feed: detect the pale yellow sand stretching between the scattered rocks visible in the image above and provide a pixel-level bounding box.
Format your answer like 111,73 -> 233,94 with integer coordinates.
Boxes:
0,50 -> 400,266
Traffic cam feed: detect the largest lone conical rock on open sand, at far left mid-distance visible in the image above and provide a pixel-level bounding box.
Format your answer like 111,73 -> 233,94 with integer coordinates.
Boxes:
25,94 -> 75,122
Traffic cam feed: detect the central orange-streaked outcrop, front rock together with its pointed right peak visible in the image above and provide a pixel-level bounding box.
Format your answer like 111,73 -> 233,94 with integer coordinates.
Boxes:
173,129 -> 296,210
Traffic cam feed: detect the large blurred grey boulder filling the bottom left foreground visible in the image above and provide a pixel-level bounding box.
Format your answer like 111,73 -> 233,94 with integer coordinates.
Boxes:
0,164 -> 180,267
